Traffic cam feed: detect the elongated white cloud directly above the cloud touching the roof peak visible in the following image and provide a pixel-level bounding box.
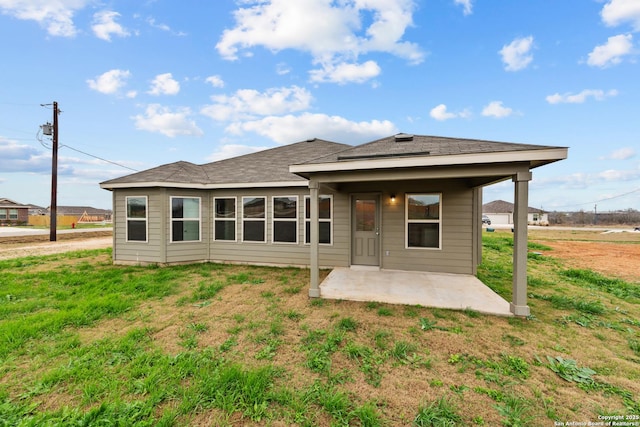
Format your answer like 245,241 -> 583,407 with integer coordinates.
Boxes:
200,86 -> 313,121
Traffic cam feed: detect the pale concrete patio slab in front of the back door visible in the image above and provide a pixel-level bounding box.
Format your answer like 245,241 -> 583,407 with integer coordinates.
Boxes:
320,268 -> 512,316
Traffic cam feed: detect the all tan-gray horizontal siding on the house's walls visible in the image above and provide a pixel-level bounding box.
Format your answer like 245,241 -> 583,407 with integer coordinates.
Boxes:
114,180 -> 475,274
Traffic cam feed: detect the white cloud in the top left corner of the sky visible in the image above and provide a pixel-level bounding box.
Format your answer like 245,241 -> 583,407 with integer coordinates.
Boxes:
0,0 -> 89,37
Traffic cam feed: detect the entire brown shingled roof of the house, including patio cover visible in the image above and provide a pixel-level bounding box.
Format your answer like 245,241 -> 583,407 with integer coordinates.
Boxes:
100,134 -> 567,189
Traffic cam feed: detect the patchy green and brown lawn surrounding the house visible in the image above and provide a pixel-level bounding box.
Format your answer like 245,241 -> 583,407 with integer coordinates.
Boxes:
0,237 -> 640,426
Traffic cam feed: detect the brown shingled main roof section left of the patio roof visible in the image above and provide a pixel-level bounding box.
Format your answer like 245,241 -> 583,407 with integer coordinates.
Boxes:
100,139 -> 351,189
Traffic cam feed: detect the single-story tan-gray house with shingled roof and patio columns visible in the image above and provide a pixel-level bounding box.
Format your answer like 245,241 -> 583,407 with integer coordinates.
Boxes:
100,134 -> 568,316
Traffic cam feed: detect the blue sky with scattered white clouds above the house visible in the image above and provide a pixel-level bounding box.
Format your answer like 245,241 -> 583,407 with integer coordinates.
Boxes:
0,0 -> 640,211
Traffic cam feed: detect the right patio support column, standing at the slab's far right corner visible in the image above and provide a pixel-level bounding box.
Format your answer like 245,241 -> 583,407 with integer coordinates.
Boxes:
510,172 -> 532,317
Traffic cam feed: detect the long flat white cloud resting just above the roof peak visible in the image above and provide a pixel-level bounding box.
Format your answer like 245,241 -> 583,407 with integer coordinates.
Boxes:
226,113 -> 398,144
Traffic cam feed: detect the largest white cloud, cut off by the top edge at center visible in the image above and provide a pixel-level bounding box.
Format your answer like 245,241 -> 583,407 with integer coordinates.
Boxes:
216,0 -> 424,83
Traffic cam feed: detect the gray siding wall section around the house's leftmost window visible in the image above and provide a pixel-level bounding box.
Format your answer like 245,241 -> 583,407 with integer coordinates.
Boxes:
113,188 -> 165,263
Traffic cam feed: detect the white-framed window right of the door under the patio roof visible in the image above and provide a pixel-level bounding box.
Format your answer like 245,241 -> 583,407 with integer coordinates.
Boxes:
405,194 -> 442,249
